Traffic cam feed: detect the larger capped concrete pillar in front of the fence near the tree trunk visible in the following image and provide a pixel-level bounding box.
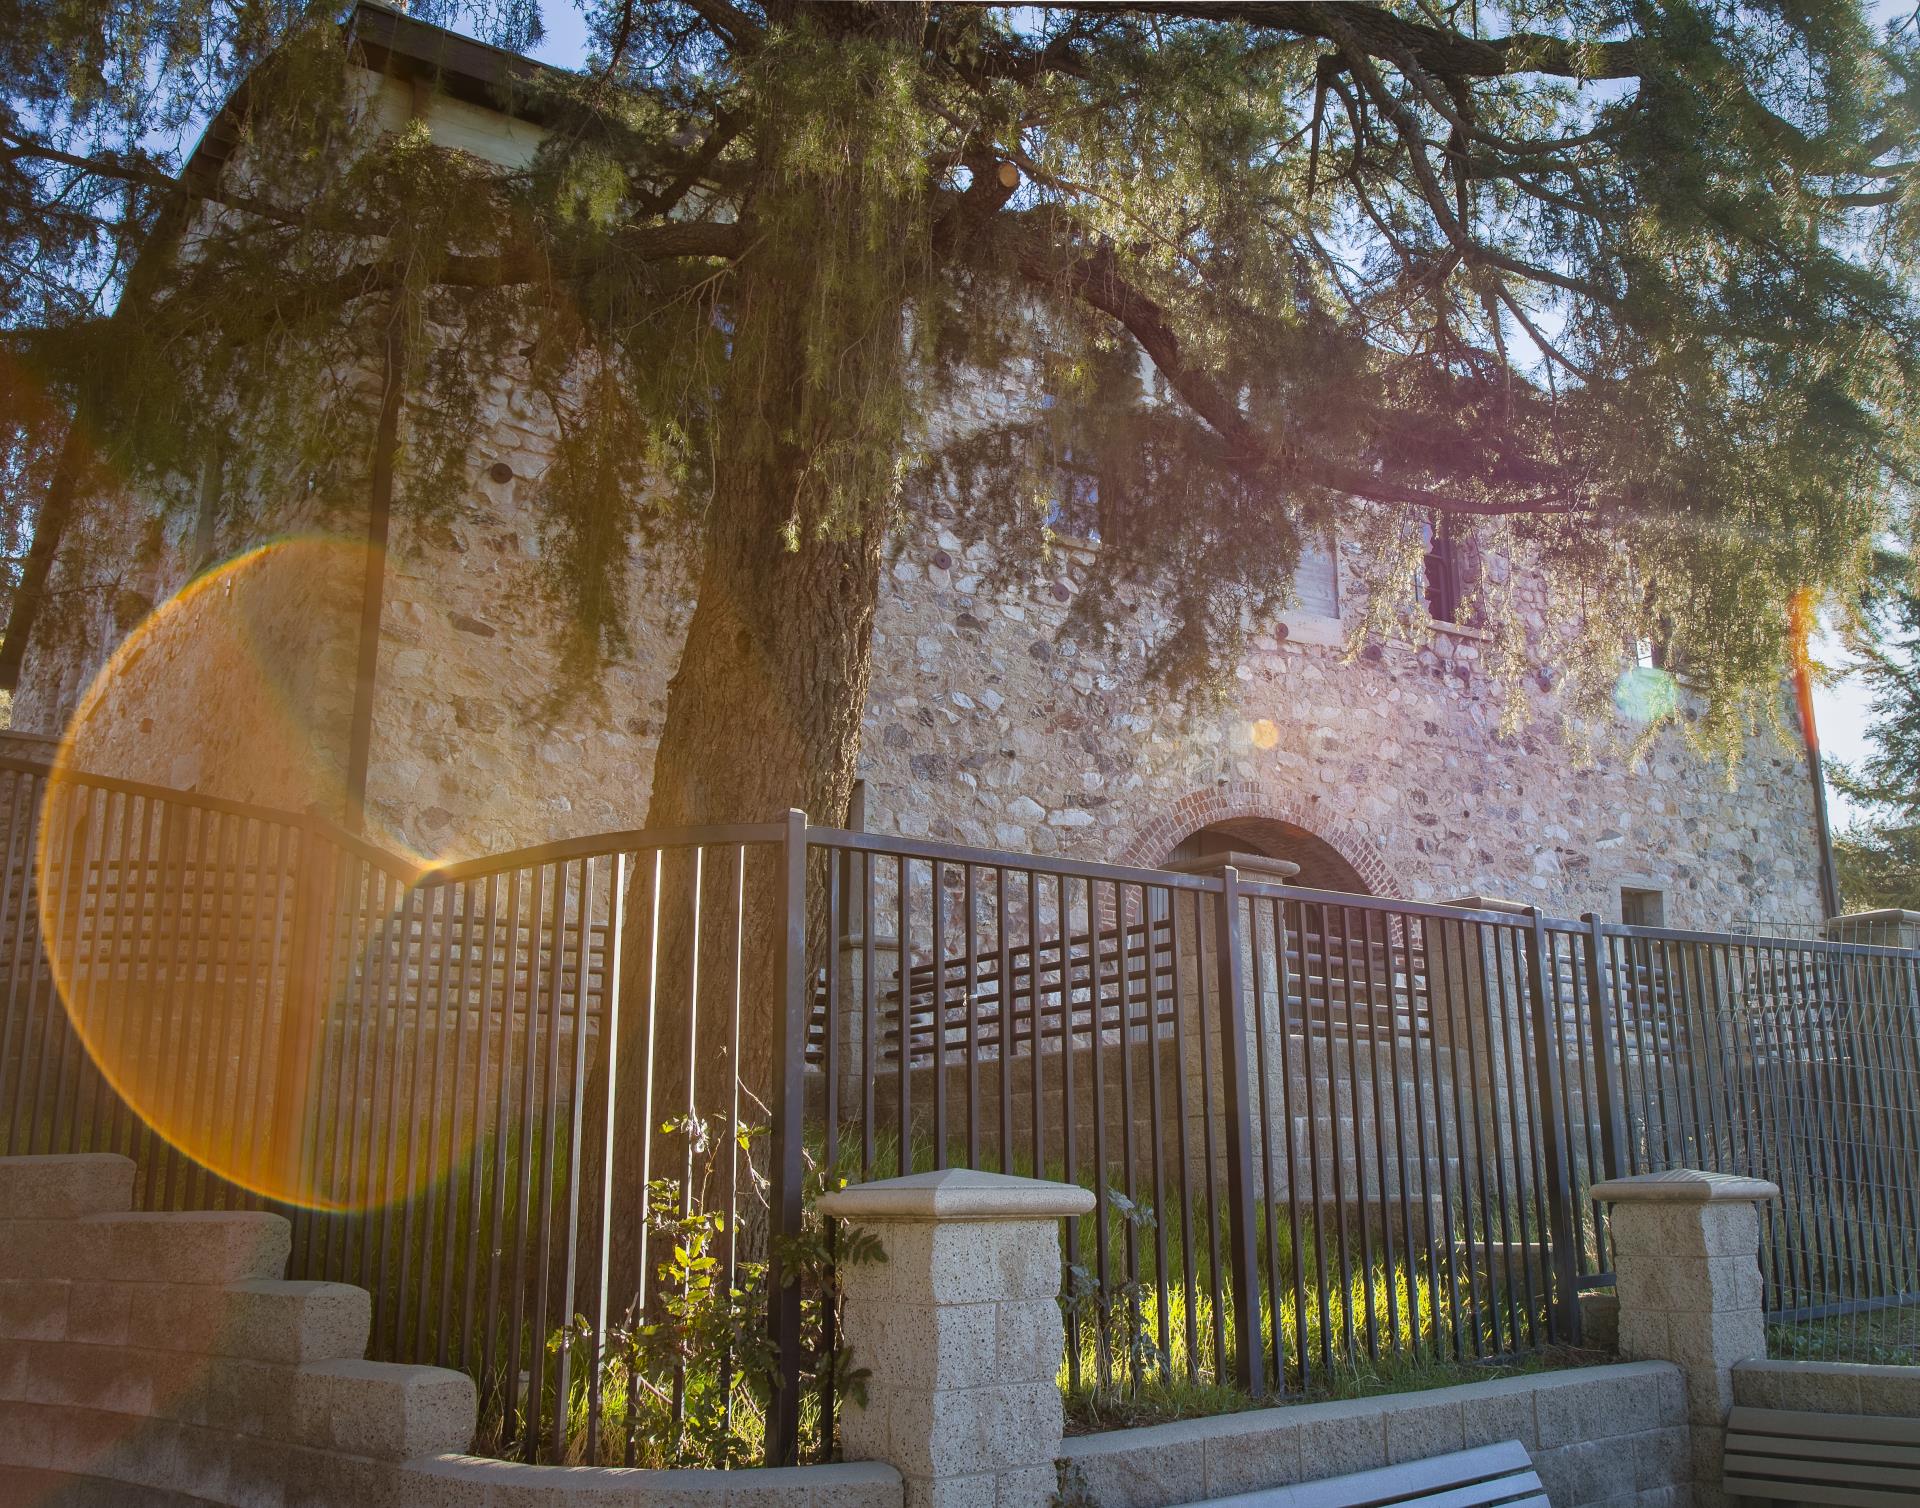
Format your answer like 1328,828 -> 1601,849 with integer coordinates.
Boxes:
820,1168 -> 1092,1508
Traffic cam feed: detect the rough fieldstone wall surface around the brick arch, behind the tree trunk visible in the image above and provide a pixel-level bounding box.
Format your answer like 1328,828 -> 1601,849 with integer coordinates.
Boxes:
15,432 -> 1818,926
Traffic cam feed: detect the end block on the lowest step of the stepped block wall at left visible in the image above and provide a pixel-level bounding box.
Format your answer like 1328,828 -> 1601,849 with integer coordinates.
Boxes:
292,1360 -> 478,1460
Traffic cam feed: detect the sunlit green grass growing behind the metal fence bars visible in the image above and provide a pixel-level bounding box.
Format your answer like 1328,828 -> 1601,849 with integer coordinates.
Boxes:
18,1118 -> 1620,1466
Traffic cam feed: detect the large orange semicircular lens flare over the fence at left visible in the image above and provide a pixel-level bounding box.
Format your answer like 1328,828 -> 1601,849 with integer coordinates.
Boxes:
35,538 -> 435,1208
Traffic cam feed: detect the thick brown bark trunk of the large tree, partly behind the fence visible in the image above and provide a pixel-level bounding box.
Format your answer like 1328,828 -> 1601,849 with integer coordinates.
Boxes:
560,6 -> 927,1443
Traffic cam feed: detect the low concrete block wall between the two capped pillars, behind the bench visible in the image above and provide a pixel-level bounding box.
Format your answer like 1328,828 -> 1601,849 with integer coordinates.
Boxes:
1062,1362 -> 1692,1508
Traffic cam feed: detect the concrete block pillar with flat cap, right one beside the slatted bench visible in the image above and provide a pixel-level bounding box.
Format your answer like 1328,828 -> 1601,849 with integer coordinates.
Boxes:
1592,1168 -> 1780,1508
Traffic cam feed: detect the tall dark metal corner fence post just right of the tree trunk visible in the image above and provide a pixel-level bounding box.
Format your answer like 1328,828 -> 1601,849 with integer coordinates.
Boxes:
766,811 -> 806,1466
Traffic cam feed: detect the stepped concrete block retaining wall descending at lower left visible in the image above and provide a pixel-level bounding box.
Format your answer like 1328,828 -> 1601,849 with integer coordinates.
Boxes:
0,1155 -> 900,1508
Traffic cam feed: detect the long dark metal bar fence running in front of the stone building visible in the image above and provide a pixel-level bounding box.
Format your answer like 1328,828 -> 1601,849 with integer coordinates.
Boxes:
0,761 -> 1920,1464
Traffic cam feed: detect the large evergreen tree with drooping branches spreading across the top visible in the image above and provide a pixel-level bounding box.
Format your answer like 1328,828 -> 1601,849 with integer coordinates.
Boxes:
11,0 -> 1920,1306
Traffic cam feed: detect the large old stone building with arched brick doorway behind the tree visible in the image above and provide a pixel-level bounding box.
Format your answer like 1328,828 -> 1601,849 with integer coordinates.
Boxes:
13,4 -> 1820,926
